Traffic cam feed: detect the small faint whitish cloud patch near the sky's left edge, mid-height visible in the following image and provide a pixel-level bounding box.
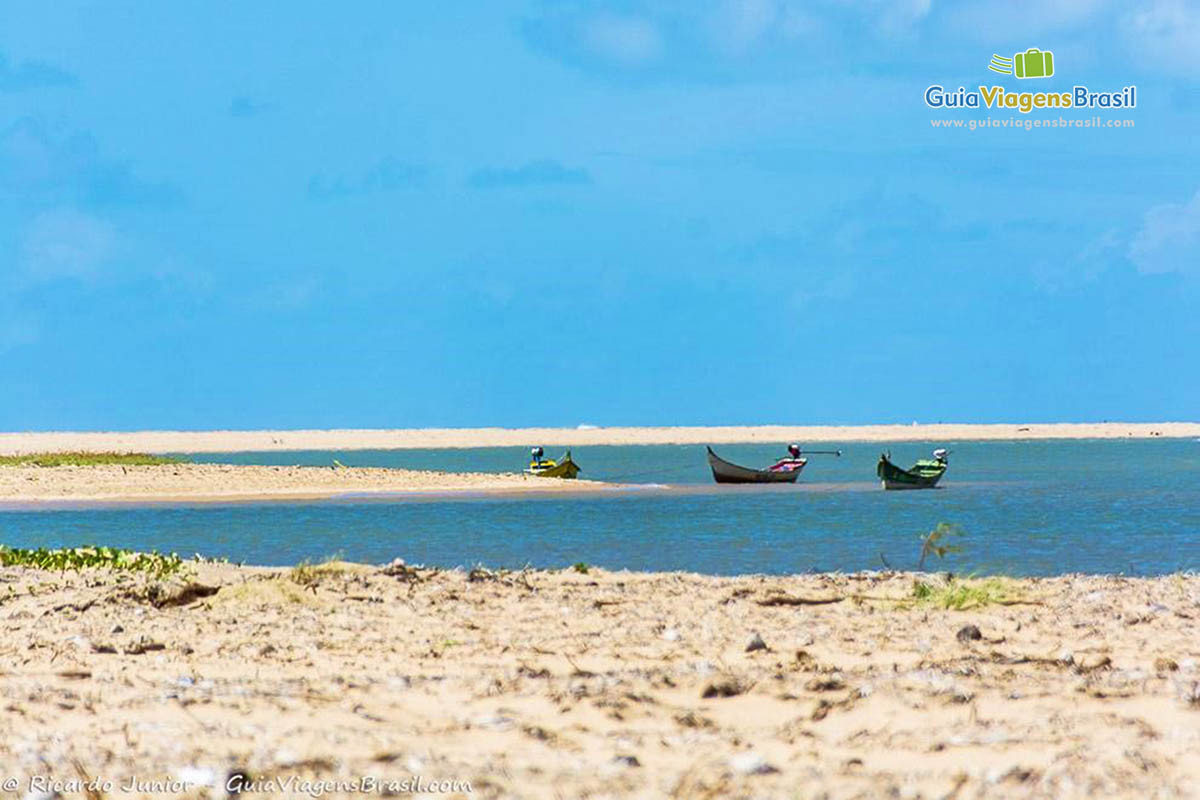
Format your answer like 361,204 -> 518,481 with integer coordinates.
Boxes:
22,209 -> 116,281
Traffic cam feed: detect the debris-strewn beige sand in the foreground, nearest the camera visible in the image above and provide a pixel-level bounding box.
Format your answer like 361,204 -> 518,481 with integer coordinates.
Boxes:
0,565 -> 1200,799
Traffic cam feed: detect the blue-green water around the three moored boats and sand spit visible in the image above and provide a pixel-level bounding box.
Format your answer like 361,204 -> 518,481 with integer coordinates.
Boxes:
0,440 -> 1200,575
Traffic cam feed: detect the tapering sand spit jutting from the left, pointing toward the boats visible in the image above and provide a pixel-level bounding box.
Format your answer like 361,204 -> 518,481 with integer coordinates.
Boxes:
0,464 -> 614,503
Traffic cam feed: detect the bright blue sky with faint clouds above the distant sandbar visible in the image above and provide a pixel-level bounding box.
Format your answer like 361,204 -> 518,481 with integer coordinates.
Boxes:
0,0 -> 1200,431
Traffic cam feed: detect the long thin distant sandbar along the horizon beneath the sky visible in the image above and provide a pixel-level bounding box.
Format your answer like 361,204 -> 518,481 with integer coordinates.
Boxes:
0,422 -> 1200,455
